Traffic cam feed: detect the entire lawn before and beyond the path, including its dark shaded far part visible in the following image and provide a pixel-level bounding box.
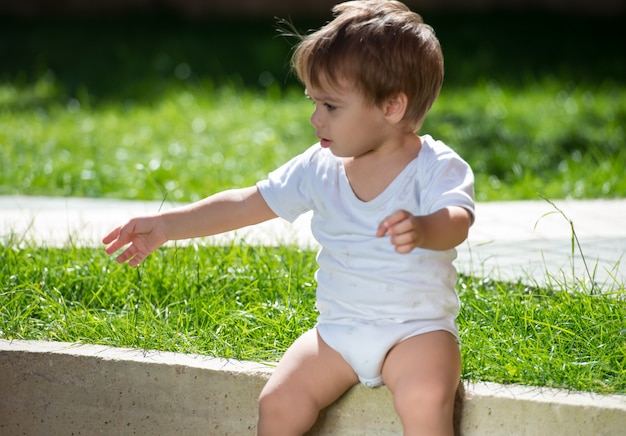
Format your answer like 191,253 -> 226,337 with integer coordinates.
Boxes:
0,14 -> 626,394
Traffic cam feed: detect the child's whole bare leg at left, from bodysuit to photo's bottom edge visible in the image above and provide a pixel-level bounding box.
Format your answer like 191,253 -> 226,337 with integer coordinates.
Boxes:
257,329 -> 358,436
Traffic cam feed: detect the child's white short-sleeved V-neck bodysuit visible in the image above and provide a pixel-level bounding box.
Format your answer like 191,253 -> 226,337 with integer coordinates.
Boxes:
257,135 -> 474,387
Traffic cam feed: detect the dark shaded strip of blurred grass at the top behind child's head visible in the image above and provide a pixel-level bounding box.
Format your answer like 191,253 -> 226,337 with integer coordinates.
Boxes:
0,12 -> 626,102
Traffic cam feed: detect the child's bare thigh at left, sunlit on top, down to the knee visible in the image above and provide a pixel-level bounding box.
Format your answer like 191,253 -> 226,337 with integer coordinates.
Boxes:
261,328 -> 358,409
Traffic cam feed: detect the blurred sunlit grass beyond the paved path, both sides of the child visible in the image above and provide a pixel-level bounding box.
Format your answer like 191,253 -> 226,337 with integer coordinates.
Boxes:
0,79 -> 626,201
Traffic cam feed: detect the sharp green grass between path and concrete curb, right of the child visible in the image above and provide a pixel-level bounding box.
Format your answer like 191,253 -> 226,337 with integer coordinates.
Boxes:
458,277 -> 626,394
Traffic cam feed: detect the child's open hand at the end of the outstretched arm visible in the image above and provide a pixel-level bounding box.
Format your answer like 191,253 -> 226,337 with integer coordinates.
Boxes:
102,215 -> 168,267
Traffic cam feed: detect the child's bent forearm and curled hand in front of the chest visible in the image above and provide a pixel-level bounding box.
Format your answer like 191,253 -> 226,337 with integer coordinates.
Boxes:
376,206 -> 472,253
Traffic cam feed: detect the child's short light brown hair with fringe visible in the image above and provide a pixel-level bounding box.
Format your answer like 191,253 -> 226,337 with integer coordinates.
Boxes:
291,0 -> 443,131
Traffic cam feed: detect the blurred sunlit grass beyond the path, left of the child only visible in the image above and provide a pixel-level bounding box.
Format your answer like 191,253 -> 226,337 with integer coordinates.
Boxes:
0,85 -> 314,201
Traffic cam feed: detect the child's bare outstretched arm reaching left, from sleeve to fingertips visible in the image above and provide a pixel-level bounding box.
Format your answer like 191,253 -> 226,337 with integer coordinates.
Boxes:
102,186 -> 276,266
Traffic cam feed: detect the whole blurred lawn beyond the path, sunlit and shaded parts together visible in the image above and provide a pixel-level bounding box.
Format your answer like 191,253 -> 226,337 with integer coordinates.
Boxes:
0,7 -> 626,201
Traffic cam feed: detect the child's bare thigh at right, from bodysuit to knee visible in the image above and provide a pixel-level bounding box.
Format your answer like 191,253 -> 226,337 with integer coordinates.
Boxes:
382,330 -> 461,398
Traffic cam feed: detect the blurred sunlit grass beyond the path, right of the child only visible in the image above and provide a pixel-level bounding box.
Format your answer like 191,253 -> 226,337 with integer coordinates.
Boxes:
425,79 -> 626,201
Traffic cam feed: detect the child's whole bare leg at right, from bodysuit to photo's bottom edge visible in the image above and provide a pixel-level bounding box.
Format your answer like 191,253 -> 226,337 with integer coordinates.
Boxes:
383,331 -> 461,436
